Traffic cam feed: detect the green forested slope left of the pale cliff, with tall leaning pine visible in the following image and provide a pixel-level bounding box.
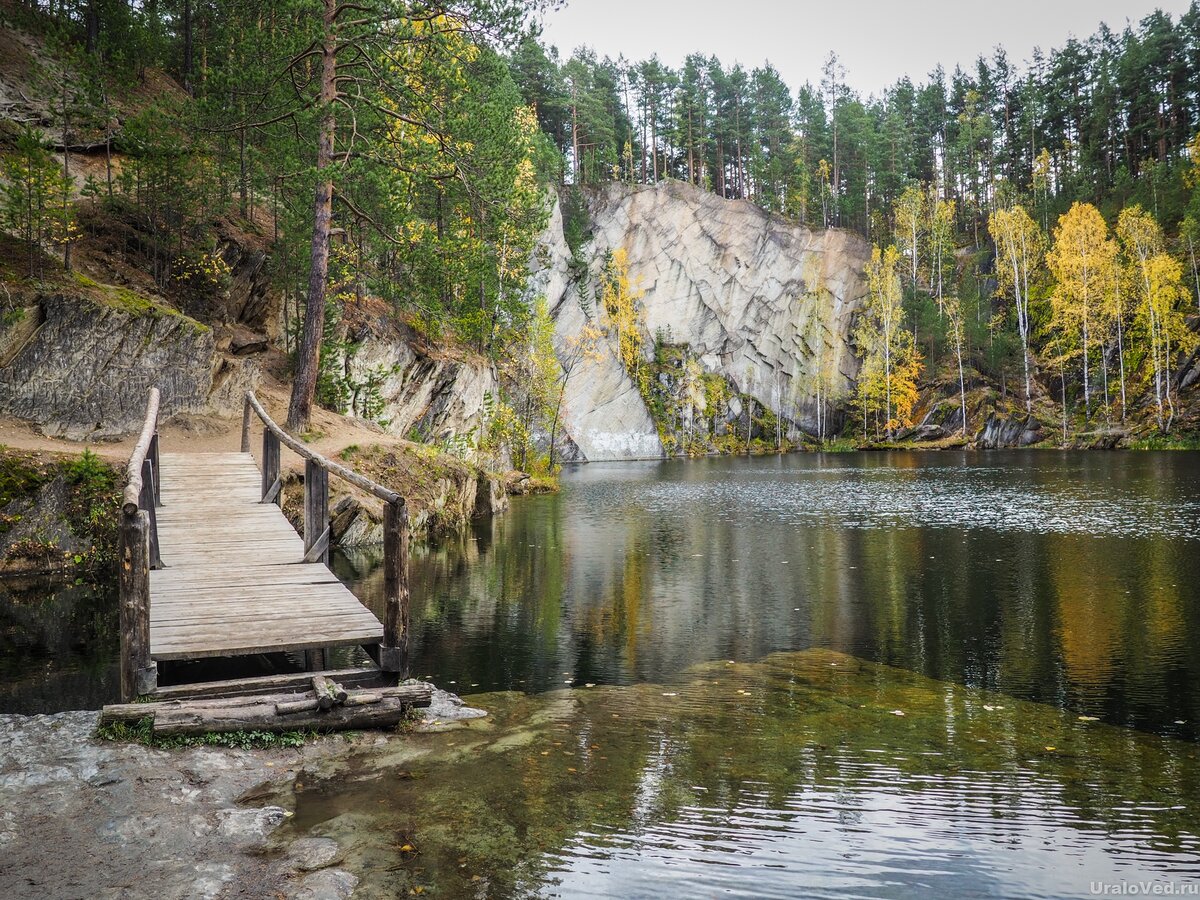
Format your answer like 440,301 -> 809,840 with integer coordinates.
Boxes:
0,0 -> 557,458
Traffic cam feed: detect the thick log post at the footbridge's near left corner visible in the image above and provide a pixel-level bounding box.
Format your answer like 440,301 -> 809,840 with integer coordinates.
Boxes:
119,510 -> 158,702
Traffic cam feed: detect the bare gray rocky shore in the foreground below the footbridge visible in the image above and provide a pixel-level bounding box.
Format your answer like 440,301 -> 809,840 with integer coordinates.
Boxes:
0,691 -> 484,900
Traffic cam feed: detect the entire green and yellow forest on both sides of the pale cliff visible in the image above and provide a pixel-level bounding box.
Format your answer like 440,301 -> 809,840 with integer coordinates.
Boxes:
0,0 -> 1200,451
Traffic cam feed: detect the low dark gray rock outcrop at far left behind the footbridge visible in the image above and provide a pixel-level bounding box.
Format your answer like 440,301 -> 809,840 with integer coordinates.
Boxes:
0,295 -> 257,440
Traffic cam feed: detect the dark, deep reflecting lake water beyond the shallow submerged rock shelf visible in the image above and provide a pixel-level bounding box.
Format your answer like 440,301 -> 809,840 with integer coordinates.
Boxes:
358,452 -> 1200,737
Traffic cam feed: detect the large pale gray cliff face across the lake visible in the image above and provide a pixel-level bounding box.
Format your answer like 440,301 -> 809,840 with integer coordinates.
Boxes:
530,182 -> 870,460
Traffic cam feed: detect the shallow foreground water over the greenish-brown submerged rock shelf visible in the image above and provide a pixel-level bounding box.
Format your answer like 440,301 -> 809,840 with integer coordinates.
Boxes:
284,650 -> 1200,898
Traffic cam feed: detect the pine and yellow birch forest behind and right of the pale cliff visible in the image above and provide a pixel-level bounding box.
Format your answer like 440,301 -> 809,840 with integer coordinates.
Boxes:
512,5 -> 1200,438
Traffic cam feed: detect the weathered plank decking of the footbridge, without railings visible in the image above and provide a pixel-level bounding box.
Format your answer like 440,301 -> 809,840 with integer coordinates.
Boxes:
150,452 -> 384,660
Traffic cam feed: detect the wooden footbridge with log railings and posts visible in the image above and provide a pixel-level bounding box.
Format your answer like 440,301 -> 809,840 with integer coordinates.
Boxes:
106,389 -> 428,731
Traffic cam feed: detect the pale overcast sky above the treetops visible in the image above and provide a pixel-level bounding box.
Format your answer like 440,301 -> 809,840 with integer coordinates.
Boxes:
544,0 -> 1190,95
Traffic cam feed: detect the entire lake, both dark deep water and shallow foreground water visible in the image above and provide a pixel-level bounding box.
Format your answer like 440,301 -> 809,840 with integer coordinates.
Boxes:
7,452 -> 1200,898
